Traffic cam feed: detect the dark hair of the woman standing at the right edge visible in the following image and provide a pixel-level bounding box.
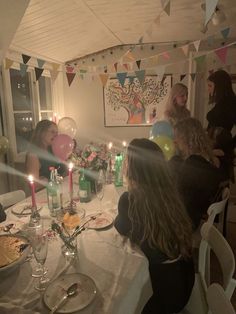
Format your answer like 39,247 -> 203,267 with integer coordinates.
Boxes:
208,70 -> 235,102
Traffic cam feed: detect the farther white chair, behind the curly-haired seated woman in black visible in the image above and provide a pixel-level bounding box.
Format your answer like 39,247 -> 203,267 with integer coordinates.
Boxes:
193,187 -> 230,248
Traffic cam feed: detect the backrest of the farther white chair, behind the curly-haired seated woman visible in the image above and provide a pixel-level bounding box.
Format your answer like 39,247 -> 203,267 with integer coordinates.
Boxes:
207,187 -> 230,232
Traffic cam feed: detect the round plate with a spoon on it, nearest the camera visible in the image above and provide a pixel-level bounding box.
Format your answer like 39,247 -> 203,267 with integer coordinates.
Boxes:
44,273 -> 97,313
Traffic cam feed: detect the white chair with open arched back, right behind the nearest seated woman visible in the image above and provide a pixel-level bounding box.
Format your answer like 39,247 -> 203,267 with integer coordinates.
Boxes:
181,223 -> 236,314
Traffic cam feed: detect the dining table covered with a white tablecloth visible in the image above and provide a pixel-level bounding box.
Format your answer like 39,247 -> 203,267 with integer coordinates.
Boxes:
0,178 -> 152,314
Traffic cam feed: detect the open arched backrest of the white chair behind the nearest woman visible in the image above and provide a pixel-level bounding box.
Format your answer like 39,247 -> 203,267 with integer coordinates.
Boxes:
198,223 -> 236,299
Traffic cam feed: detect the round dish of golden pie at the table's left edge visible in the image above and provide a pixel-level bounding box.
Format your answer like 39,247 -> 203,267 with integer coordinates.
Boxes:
0,234 -> 30,274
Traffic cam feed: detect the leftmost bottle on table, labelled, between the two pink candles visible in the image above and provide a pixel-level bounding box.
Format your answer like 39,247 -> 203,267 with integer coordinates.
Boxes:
47,167 -> 61,217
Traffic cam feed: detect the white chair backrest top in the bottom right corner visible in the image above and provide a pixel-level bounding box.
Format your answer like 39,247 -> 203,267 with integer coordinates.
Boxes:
207,283 -> 235,314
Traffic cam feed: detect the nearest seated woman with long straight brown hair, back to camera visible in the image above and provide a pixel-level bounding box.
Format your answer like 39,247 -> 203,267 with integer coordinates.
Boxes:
114,138 -> 194,314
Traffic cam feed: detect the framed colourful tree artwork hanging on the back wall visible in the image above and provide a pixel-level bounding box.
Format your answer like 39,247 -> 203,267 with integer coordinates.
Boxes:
103,75 -> 172,127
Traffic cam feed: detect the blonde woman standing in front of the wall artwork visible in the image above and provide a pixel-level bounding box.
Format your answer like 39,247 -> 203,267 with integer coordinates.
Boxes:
164,83 -> 190,126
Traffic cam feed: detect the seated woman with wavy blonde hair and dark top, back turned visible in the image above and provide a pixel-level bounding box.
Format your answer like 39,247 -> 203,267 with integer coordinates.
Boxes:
169,118 -> 224,230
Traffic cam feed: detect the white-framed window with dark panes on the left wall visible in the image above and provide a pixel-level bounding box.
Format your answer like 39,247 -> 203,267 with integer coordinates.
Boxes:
9,69 -> 53,153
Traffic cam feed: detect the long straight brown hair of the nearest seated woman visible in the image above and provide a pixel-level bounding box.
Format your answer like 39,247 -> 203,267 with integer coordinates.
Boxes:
127,138 -> 192,259
